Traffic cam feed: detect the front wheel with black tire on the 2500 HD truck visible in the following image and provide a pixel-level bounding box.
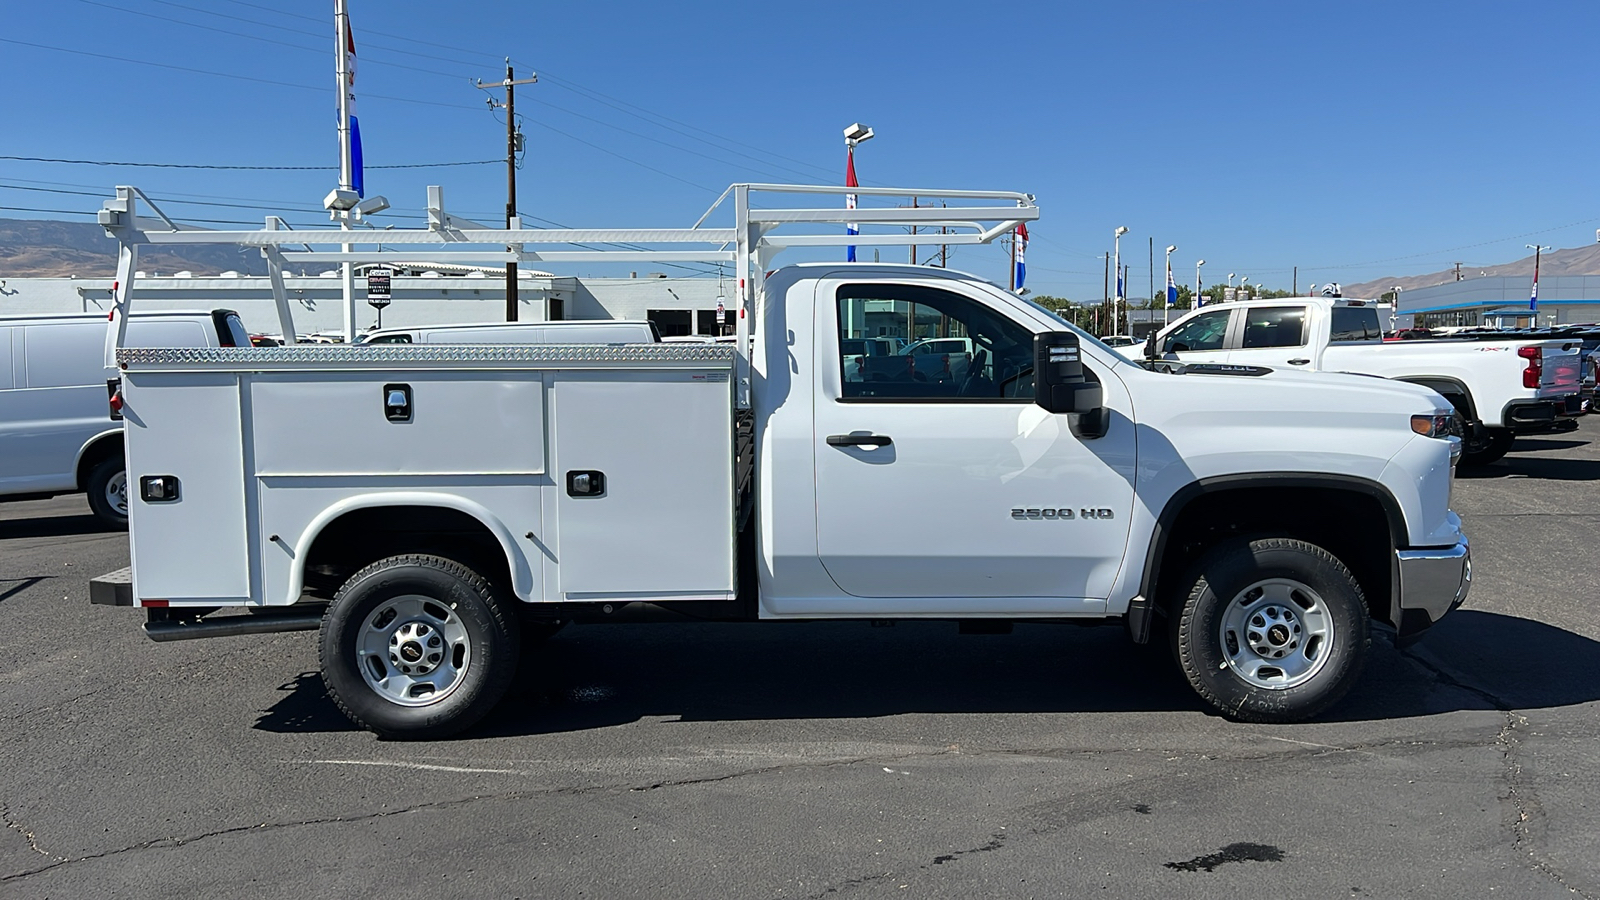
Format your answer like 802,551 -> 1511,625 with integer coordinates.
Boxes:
1170,538 -> 1371,722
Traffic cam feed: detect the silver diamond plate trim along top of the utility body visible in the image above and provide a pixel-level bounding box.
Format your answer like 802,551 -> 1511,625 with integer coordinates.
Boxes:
117,343 -> 734,367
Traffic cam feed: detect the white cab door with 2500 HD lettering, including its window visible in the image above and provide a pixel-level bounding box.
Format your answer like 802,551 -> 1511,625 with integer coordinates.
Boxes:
813,279 -> 1134,602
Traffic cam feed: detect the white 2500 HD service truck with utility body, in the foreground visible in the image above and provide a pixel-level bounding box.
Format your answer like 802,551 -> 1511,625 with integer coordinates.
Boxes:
91,187 -> 1470,738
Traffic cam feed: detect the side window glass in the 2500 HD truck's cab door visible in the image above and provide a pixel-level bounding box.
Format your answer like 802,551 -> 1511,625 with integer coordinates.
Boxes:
837,285 -> 1034,402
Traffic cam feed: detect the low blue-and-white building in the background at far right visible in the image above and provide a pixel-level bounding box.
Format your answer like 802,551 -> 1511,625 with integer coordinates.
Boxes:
1395,275 -> 1600,328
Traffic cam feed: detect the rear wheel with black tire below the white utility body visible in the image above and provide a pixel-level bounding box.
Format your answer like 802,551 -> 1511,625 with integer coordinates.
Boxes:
318,556 -> 518,740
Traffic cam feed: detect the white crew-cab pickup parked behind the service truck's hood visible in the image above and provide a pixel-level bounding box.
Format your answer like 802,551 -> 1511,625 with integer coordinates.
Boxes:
1146,296 -> 1582,464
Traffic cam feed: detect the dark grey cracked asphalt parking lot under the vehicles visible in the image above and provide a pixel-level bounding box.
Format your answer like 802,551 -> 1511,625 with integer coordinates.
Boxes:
0,420 -> 1600,898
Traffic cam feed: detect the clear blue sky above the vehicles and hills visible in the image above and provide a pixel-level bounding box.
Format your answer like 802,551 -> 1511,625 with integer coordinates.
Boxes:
0,0 -> 1600,299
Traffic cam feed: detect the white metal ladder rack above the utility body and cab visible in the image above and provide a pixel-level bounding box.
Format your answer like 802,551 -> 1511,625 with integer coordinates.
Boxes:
99,184 -> 1038,408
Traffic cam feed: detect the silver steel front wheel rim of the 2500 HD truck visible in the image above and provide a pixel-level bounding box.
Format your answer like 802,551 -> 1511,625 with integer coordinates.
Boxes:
1218,578 -> 1334,690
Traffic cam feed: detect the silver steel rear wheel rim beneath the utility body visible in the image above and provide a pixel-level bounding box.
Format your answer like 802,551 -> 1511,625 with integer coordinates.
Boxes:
355,594 -> 472,706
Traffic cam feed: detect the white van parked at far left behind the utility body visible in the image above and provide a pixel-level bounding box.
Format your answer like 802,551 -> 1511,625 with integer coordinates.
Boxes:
0,309 -> 250,528
